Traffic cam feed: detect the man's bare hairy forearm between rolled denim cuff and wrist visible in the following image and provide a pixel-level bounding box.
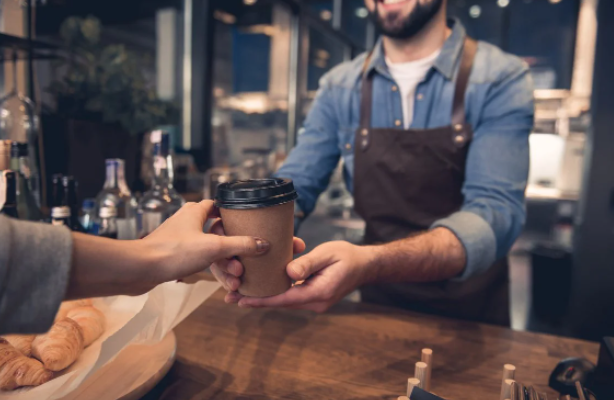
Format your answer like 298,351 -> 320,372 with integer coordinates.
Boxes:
366,228 -> 466,283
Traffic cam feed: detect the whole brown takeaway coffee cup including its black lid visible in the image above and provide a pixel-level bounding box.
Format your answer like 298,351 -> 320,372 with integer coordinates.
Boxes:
215,178 -> 298,297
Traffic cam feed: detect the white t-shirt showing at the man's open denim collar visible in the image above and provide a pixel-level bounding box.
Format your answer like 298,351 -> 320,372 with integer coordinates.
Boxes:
386,50 -> 441,129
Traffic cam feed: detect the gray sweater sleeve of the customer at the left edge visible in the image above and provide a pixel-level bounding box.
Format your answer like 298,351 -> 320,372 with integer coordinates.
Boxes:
0,215 -> 72,334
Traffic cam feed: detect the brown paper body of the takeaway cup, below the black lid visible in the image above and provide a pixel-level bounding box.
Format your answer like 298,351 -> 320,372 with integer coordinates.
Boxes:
220,201 -> 294,297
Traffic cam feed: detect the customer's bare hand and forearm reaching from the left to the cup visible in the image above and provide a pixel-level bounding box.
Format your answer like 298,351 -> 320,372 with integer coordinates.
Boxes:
66,200 -> 269,299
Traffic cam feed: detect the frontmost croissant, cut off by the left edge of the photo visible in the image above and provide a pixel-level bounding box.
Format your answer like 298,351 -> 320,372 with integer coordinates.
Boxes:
0,338 -> 53,390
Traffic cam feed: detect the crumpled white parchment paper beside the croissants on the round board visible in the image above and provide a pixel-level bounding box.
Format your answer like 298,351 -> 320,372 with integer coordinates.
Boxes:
0,281 -> 220,400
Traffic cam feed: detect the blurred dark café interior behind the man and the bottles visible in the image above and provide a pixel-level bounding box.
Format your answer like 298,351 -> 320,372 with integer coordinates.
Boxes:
0,0 -> 614,338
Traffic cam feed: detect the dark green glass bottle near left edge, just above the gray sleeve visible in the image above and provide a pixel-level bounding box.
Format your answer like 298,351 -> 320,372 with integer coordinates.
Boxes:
11,142 -> 42,221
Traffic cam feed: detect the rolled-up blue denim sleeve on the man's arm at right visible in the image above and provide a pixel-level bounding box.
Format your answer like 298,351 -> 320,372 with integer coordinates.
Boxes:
432,61 -> 534,280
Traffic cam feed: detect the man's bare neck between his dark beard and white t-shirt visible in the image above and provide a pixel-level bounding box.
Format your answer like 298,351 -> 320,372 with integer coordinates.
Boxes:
383,13 -> 452,64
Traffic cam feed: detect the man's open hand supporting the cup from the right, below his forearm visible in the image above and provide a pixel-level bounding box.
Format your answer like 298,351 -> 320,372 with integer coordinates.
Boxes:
226,242 -> 372,312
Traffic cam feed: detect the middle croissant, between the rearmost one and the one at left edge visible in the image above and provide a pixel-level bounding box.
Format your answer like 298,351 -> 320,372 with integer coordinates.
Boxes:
32,318 -> 83,371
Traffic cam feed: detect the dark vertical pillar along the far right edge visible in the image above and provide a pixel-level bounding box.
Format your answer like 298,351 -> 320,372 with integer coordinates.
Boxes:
570,0 -> 614,339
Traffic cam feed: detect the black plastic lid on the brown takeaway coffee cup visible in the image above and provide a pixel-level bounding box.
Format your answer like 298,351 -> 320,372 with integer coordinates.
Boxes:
215,178 -> 298,210
